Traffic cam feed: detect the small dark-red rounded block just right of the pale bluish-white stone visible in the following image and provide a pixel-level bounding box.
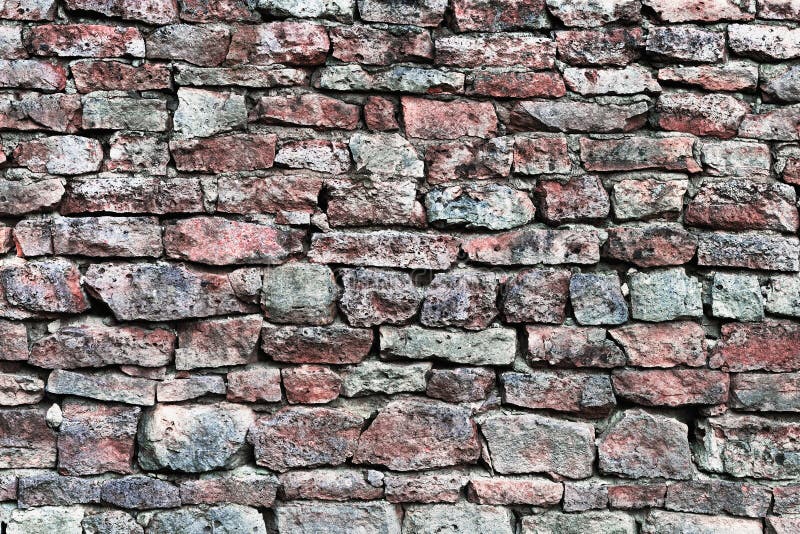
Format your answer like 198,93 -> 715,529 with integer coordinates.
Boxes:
535,176 -> 611,224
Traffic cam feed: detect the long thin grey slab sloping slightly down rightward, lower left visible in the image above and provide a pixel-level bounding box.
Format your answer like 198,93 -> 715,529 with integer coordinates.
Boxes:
47,369 -> 156,406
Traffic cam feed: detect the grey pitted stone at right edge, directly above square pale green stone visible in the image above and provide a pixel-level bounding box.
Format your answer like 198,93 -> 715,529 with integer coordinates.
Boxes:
697,232 -> 800,271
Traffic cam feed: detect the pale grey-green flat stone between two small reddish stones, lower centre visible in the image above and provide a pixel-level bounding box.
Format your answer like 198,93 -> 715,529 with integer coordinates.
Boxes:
340,360 -> 432,397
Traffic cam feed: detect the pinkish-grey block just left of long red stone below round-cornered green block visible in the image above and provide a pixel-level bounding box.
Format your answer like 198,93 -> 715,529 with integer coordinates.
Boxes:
175,315 -> 262,370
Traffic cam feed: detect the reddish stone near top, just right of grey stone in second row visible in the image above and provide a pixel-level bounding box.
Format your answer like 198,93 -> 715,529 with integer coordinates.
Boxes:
227,21 -> 330,65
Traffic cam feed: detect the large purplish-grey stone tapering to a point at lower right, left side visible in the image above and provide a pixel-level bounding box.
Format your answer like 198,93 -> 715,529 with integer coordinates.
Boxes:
85,262 -> 254,321
